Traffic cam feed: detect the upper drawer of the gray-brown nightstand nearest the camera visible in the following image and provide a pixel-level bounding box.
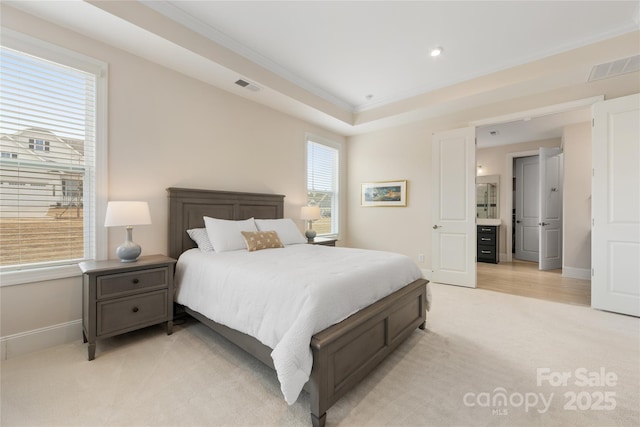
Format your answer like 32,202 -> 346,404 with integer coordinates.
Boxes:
97,268 -> 168,299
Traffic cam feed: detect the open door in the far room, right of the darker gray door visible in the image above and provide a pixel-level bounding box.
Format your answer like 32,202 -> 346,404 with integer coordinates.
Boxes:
538,147 -> 563,270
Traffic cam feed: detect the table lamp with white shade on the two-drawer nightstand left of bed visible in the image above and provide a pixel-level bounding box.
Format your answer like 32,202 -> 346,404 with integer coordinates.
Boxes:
104,202 -> 151,262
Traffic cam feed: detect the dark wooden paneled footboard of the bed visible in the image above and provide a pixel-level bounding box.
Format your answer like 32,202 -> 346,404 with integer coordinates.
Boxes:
307,279 -> 428,427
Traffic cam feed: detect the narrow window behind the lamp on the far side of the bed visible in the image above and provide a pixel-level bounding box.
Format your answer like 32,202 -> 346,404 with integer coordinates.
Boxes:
307,137 -> 340,235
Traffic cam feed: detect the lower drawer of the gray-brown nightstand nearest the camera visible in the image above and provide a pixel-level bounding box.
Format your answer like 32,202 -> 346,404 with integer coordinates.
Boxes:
96,290 -> 168,336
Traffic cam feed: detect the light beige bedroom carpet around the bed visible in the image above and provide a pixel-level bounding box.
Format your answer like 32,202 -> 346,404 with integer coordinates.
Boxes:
0,284 -> 640,426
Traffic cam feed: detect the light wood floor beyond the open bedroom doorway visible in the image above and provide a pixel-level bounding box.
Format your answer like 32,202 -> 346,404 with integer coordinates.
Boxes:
477,261 -> 591,306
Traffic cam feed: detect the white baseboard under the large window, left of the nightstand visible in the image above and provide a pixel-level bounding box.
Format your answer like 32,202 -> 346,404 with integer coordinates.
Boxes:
0,319 -> 82,360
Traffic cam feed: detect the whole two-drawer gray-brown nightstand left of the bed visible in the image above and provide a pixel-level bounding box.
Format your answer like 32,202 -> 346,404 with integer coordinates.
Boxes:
79,255 -> 176,360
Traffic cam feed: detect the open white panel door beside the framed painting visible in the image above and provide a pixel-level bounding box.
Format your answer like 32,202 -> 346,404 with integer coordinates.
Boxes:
431,127 -> 476,288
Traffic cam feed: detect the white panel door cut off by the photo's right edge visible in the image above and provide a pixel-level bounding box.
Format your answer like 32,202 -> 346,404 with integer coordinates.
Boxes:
591,94 -> 640,316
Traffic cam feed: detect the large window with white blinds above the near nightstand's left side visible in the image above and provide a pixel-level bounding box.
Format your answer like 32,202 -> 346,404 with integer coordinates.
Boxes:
0,31 -> 106,283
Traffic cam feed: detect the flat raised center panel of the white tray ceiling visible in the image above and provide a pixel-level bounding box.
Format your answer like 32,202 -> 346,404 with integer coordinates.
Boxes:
144,1 -> 638,111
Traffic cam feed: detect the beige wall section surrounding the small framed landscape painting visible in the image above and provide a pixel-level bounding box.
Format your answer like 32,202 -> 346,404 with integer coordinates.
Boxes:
347,123 -> 431,268
